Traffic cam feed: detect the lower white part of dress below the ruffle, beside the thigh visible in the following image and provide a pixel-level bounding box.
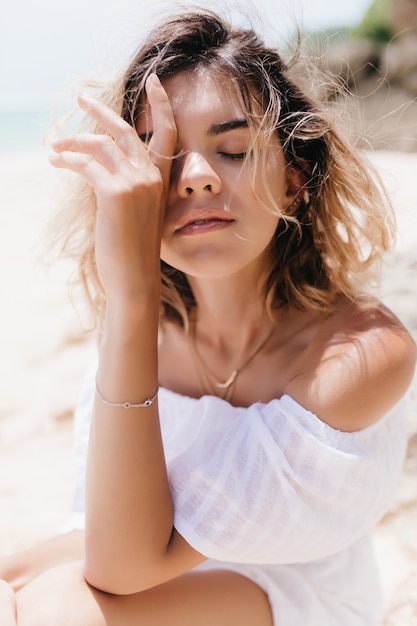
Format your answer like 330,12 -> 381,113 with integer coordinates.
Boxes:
192,536 -> 383,626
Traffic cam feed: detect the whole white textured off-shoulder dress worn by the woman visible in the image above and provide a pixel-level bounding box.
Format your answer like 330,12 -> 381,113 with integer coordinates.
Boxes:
70,372 -> 406,626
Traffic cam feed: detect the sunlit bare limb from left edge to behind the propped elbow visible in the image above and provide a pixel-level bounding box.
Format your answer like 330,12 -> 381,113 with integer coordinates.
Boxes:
0,530 -> 84,591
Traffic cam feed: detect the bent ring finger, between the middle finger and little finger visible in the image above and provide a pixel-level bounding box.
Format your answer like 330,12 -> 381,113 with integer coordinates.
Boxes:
51,133 -> 131,174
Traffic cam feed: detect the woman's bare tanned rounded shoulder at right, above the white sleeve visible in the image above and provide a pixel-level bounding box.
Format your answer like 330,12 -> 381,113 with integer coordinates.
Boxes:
285,302 -> 416,431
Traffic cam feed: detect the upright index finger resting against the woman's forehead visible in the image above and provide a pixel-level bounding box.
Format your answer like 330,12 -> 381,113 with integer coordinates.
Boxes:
146,74 -> 177,184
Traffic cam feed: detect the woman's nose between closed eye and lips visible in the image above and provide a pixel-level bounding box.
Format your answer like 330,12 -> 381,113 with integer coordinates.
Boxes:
172,152 -> 221,198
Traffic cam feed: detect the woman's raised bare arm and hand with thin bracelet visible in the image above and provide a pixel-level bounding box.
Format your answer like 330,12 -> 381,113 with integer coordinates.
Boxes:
52,79 -> 204,594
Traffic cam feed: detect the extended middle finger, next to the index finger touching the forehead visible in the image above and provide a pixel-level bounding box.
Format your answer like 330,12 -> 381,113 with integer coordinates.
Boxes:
78,94 -> 146,159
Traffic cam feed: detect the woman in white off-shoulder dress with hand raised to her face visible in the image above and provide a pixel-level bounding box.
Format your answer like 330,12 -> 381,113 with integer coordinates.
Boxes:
4,7 -> 415,626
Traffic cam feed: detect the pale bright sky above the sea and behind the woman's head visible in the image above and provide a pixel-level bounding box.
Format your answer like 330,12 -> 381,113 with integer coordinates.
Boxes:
0,0 -> 371,110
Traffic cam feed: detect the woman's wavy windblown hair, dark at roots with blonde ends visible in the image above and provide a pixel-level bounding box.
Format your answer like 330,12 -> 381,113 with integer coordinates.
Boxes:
50,11 -> 394,327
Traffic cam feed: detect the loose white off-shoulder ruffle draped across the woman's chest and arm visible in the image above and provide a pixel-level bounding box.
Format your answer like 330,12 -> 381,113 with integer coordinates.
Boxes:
160,390 -> 406,563
